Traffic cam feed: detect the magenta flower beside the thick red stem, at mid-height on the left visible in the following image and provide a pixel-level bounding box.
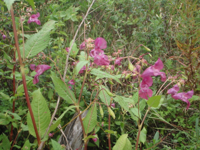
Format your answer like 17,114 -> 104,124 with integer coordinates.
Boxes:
30,64 -> 51,84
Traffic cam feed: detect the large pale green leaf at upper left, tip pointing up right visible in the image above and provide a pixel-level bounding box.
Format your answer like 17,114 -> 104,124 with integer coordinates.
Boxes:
20,20 -> 55,58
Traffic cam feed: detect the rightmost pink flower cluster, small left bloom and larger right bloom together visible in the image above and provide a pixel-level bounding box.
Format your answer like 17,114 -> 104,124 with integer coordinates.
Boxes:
167,84 -> 194,110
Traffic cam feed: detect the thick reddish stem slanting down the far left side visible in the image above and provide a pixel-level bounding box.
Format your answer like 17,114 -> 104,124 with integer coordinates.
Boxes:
10,7 -> 41,145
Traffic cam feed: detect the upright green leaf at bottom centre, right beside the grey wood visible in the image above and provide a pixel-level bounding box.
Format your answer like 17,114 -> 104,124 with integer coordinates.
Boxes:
83,103 -> 97,134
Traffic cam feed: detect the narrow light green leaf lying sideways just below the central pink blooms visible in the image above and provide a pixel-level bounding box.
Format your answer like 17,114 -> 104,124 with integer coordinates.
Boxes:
91,69 -> 121,84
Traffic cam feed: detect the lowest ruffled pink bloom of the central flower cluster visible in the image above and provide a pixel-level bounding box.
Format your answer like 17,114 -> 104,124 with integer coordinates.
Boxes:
94,54 -> 110,66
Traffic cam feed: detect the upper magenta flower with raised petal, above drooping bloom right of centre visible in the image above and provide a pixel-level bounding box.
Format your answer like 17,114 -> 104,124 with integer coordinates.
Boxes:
142,58 -> 166,82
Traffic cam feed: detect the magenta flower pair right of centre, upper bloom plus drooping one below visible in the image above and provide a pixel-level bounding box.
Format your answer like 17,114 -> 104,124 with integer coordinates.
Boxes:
139,58 -> 166,100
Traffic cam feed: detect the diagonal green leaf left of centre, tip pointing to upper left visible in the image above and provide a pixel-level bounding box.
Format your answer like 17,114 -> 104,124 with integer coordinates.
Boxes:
51,72 -> 76,104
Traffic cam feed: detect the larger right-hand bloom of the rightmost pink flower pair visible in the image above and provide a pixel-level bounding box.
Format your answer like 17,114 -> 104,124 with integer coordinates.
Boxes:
172,91 -> 194,110
